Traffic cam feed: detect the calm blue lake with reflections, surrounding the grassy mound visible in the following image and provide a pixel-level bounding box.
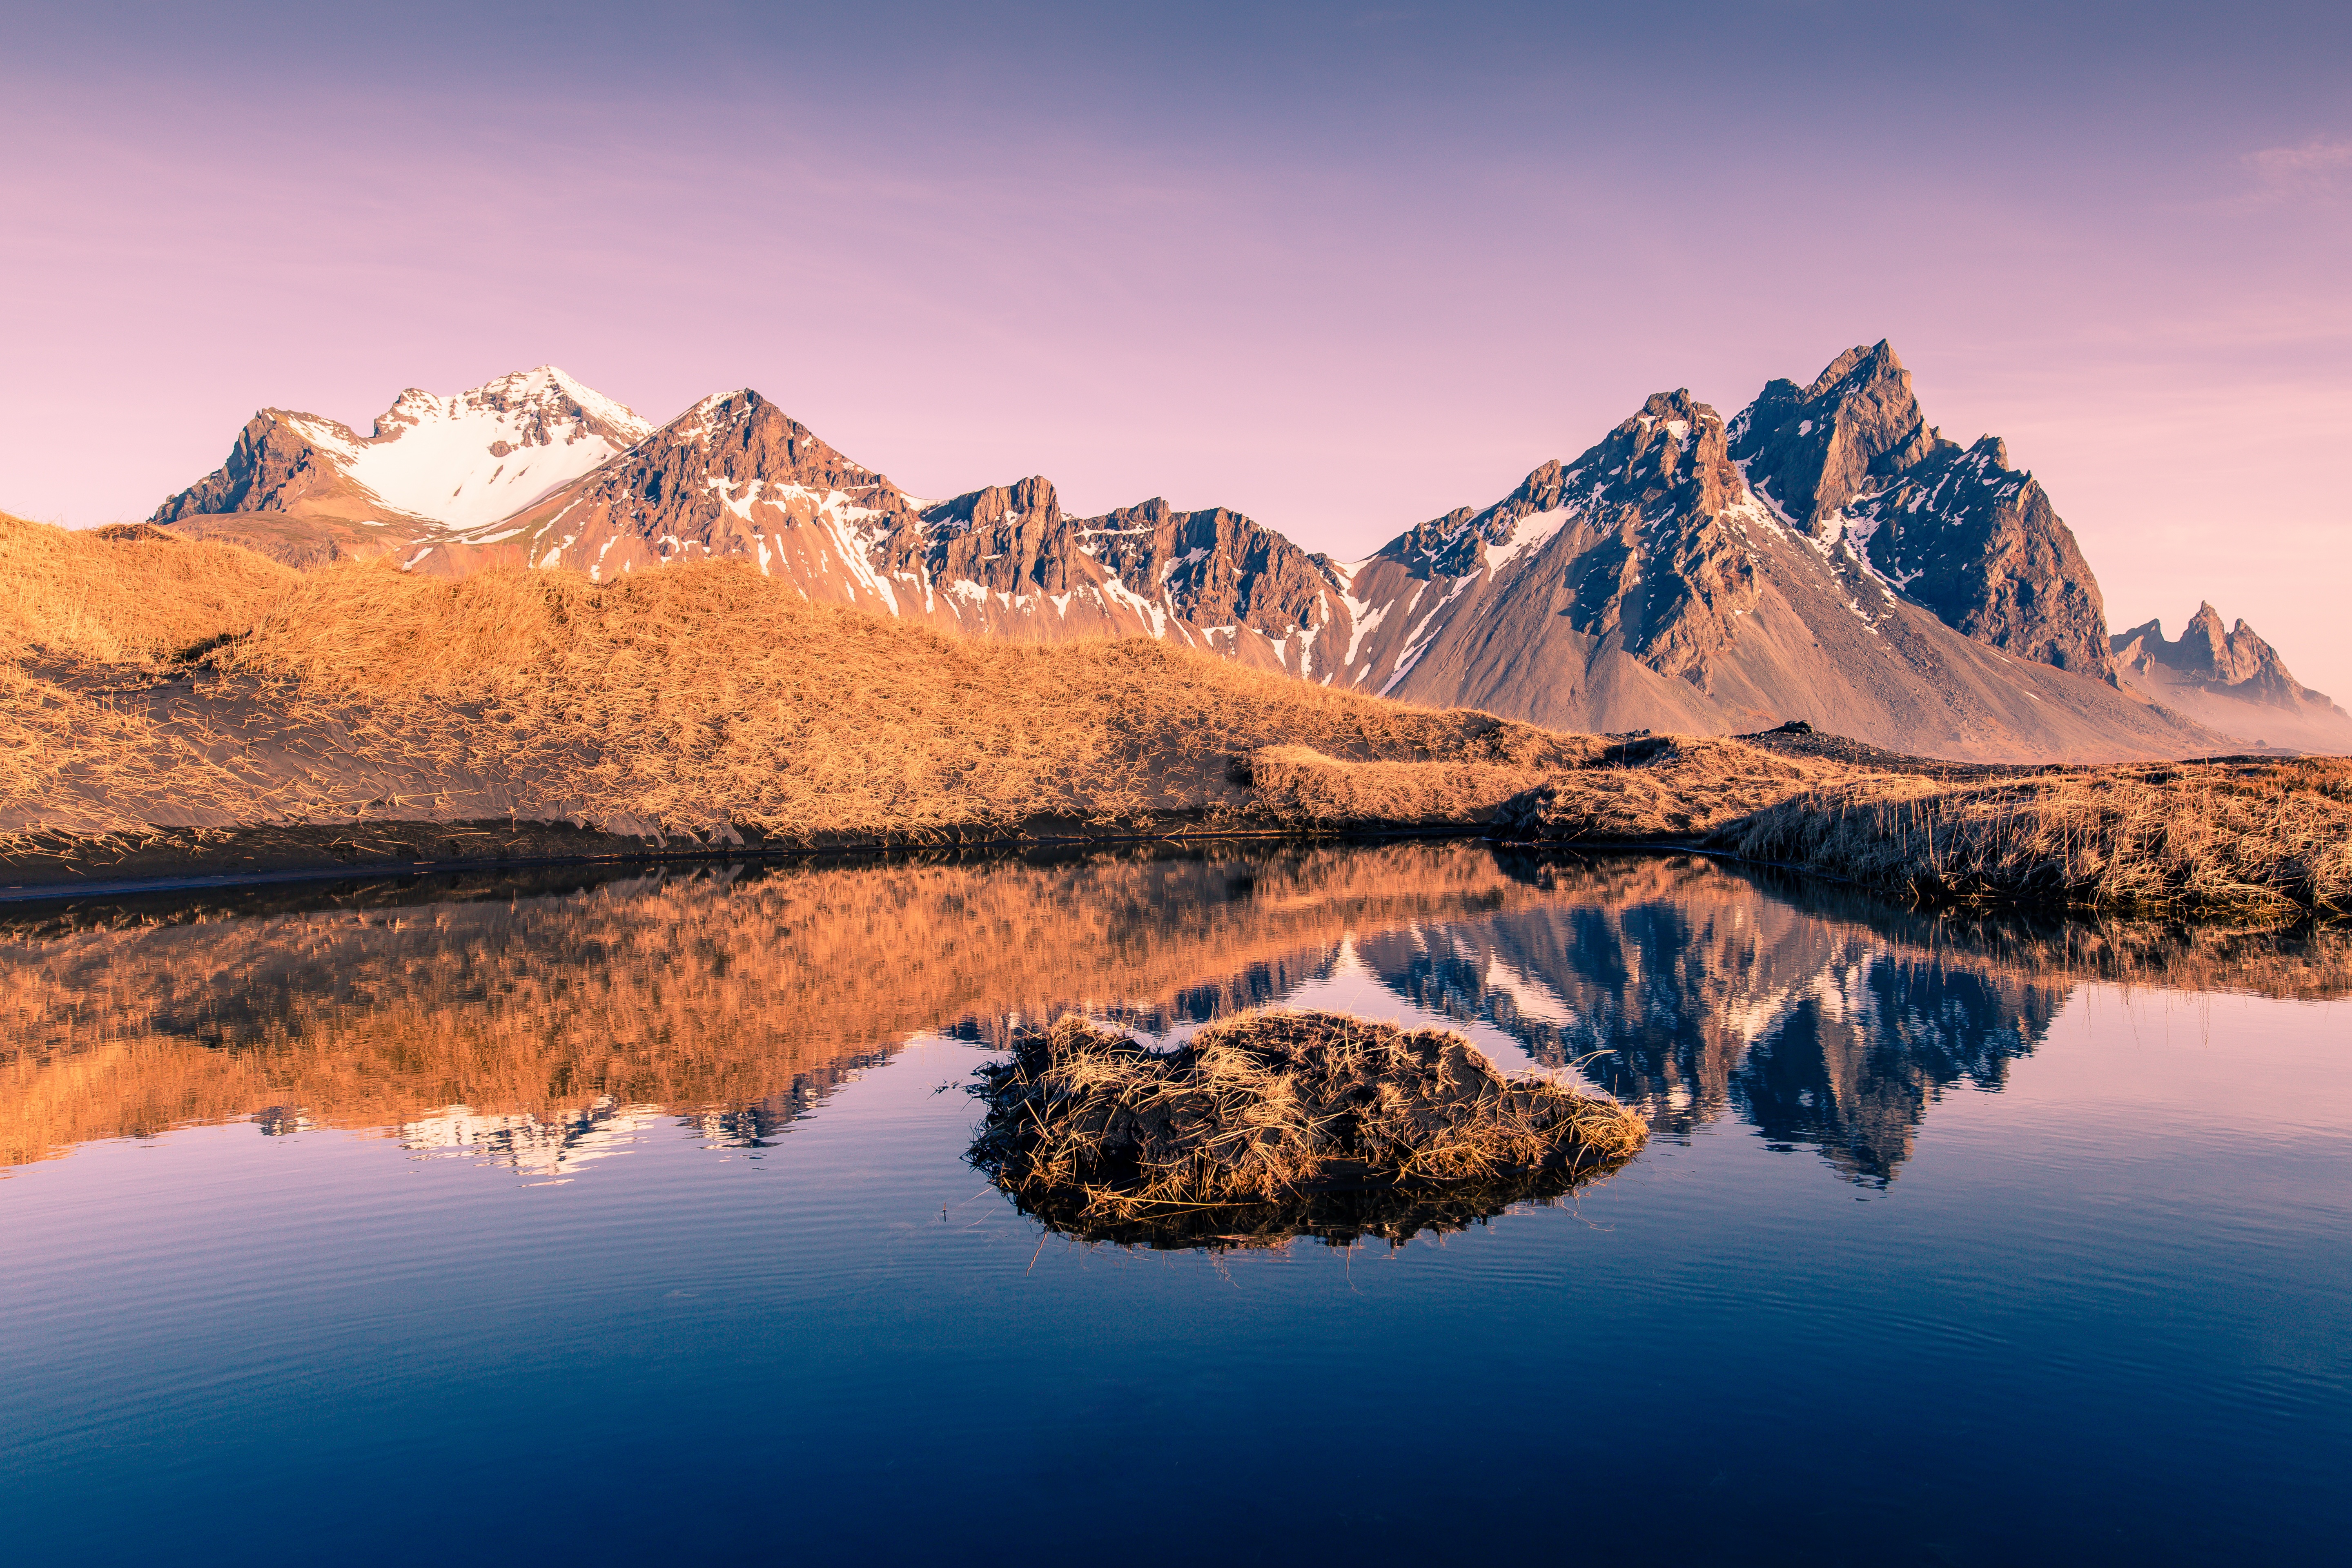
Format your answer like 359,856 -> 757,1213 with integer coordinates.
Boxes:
0,844 -> 2352,1566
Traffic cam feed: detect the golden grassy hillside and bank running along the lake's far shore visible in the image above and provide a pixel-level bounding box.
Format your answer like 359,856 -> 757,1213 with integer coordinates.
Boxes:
0,519 -> 2352,917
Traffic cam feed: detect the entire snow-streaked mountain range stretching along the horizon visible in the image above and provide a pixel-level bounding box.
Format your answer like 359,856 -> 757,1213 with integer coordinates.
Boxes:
153,343 -> 2352,760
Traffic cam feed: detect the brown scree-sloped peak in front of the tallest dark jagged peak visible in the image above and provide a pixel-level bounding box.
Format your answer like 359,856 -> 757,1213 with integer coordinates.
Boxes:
1345,392 -> 2223,760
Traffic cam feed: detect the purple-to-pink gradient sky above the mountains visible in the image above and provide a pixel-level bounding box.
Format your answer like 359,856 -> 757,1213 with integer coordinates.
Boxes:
13,0 -> 2352,701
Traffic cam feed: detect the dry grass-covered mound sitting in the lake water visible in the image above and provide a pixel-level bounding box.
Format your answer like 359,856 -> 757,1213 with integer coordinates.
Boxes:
971,1011 -> 1646,1246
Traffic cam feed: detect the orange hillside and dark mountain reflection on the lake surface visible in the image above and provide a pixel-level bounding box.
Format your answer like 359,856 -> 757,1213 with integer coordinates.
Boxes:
0,844 -> 2352,1183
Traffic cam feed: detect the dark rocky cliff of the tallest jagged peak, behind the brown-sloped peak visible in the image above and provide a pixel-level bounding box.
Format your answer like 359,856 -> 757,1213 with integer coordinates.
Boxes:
1731,343 -> 2112,679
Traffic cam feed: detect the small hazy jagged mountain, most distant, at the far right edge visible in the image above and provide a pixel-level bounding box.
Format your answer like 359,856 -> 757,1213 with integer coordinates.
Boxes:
2112,604 -> 2352,752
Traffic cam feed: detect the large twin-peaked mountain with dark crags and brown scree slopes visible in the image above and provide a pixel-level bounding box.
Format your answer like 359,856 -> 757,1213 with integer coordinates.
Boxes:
1350,355 -> 2183,760
